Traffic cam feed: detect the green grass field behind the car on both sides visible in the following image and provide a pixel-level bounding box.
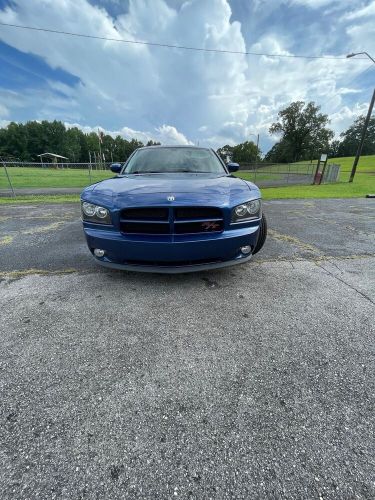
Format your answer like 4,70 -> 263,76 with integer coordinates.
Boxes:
0,155 -> 375,205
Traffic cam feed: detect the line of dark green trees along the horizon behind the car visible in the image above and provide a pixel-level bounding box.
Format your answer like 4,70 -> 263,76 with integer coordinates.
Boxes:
0,101 -> 375,163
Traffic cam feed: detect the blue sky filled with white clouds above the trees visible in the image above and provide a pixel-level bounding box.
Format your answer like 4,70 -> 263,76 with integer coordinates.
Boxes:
0,0 -> 375,152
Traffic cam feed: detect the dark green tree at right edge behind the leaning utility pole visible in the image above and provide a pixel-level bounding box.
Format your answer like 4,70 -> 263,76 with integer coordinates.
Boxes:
335,116 -> 375,156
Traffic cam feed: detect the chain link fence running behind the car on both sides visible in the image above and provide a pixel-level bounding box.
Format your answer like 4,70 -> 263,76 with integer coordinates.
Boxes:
0,161 -> 340,196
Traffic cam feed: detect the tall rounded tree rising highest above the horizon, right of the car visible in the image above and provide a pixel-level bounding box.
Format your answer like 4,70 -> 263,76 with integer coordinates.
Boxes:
269,101 -> 334,162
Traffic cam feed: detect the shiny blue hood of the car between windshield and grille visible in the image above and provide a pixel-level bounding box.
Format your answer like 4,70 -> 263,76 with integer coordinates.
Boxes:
83,174 -> 259,206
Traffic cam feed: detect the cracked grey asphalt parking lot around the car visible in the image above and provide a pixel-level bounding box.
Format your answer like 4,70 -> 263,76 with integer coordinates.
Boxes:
0,199 -> 375,499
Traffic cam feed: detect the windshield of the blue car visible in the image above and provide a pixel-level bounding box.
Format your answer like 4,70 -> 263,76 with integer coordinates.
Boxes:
122,147 -> 226,175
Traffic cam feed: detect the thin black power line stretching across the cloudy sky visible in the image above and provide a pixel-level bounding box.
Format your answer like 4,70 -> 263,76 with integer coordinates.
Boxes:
0,22 -> 366,60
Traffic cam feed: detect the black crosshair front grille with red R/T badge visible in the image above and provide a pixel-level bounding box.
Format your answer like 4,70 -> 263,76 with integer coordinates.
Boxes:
120,207 -> 224,235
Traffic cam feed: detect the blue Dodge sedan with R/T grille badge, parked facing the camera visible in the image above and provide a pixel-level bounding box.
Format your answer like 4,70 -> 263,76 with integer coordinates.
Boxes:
81,146 -> 267,273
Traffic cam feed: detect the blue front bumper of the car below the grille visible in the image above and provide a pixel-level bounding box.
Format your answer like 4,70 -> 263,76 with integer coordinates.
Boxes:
84,222 -> 259,273
